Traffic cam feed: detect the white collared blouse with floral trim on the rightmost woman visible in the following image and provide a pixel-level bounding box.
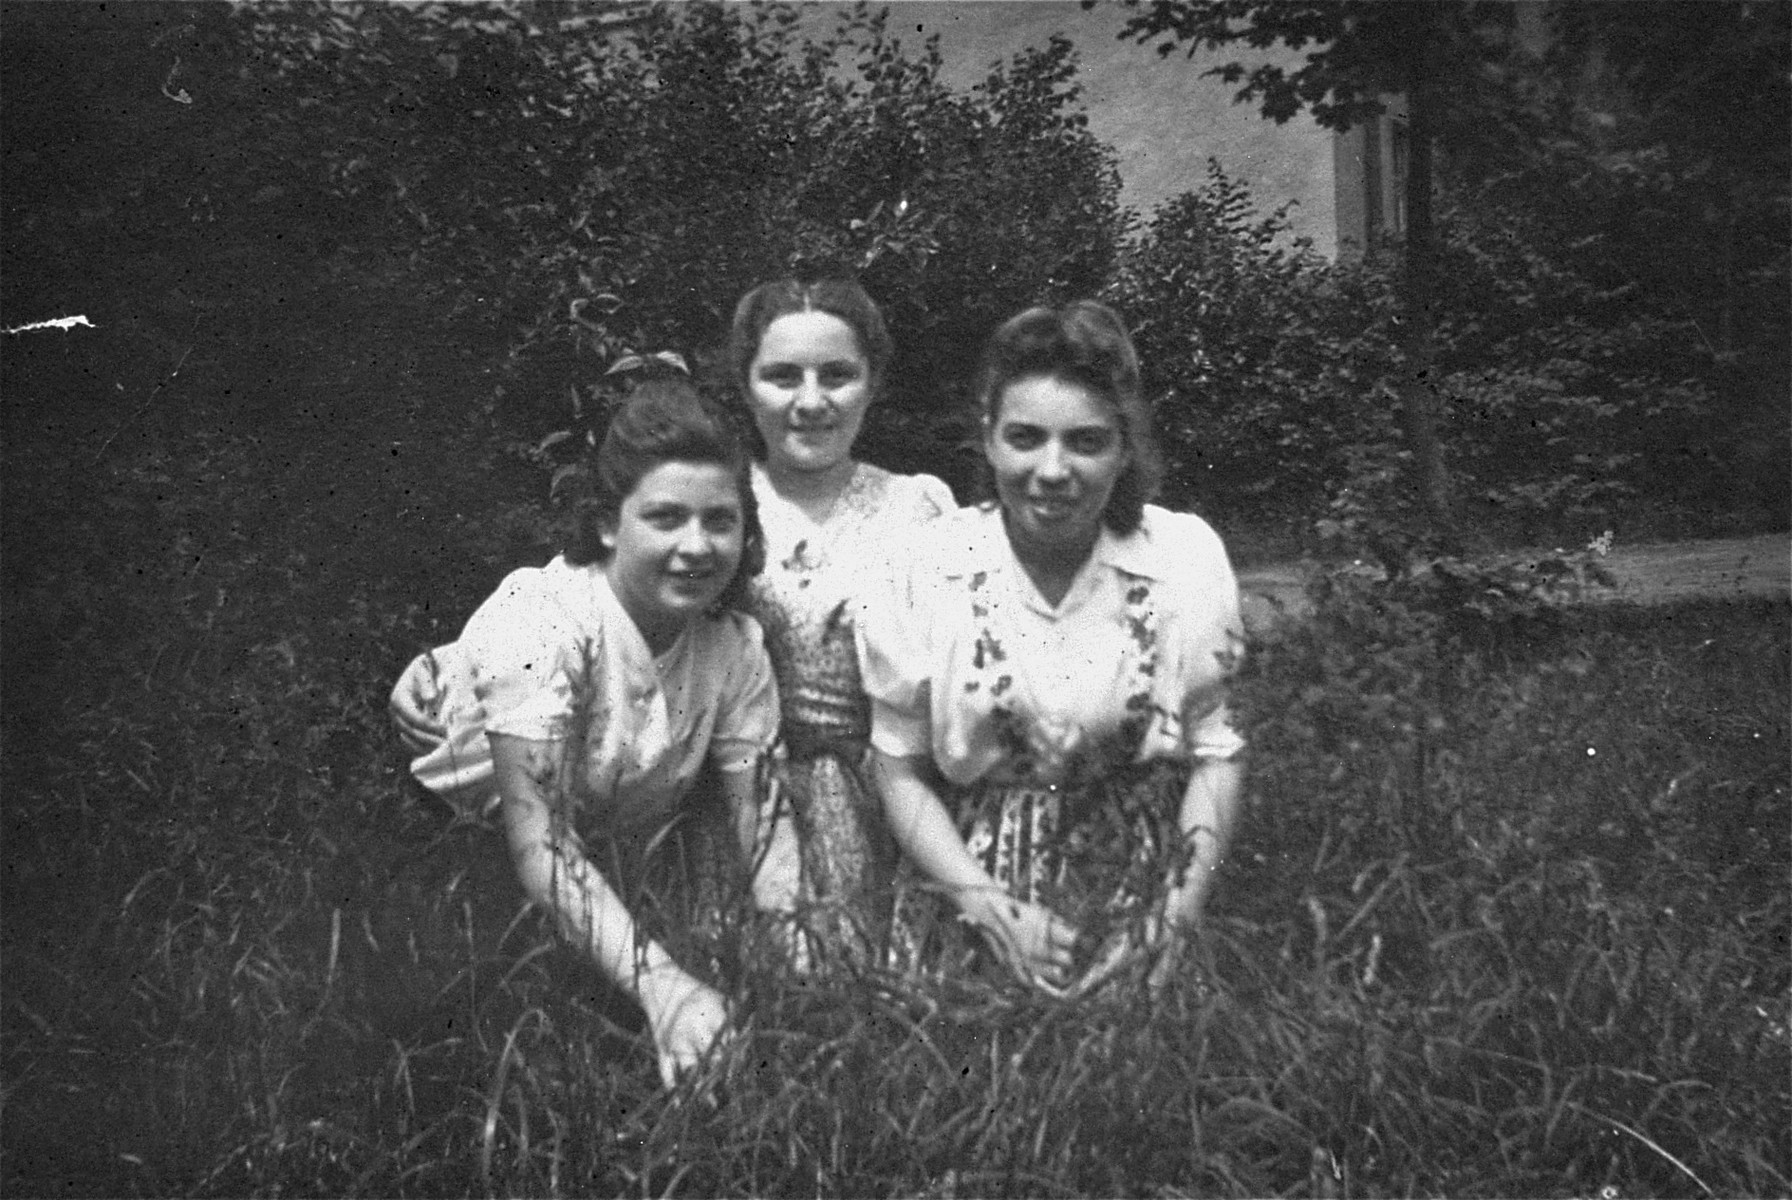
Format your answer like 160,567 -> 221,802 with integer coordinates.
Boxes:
857,505 -> 1244,784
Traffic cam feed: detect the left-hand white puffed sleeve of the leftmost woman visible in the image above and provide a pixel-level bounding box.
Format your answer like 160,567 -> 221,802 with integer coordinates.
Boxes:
461,568 -> 597,741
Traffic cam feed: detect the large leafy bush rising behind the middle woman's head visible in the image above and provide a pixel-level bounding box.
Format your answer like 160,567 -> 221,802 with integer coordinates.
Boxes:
220,5 -> 1124,483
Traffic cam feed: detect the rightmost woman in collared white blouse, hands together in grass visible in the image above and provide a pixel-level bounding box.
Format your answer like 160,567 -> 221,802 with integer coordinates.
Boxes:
858,301 -> 1244,990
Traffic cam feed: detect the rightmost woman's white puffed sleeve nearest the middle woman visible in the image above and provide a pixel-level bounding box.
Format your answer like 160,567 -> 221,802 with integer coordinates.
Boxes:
853,537 -> 934,758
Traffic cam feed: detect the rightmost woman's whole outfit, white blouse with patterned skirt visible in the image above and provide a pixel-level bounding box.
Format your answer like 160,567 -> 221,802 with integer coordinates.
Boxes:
858,507 -> 1244,988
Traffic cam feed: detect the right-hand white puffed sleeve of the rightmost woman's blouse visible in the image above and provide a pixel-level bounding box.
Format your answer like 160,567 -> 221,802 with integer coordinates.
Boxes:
1156,510 -> 1244,759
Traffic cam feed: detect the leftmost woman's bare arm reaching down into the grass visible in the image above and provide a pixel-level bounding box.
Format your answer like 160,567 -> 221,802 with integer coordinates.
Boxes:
491,734 -> 728,1087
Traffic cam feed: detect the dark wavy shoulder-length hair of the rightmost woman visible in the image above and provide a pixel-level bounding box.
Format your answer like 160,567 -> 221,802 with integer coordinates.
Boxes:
975,301 -> 1163,536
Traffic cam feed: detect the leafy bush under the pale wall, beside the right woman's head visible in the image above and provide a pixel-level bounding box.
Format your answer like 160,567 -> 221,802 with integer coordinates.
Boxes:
1111,161 -> 1392,521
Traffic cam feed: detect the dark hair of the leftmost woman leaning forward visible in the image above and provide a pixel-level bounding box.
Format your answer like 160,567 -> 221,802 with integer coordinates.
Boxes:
556,378 -> 765,607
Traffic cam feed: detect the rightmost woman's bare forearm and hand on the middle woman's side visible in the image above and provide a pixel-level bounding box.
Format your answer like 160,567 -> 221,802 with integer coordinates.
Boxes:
873,750 -> 1077,985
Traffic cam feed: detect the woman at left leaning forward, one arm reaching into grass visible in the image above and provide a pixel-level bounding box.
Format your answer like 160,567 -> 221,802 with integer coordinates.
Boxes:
413,381 -> 797,1085
